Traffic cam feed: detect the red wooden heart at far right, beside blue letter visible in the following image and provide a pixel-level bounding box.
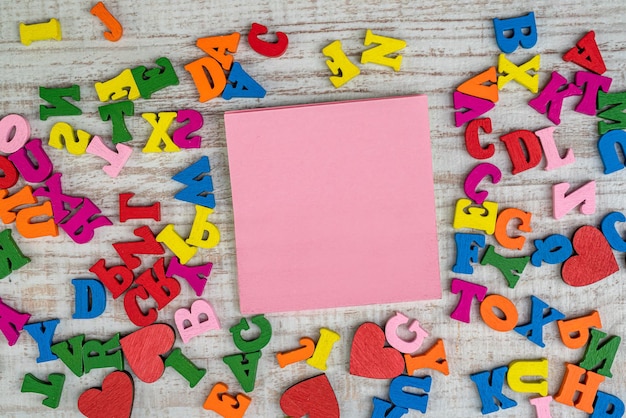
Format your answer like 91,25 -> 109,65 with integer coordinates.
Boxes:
561,225 -> 619,286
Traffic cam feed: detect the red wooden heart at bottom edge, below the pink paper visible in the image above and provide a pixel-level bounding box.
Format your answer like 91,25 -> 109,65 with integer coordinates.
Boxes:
280,374 -> 339,418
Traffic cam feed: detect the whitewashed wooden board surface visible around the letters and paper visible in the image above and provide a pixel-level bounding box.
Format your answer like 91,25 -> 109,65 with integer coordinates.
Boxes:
0,0 -> 626,417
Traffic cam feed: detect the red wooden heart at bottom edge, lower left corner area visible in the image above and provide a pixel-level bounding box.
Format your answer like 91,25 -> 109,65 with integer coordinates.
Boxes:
78,371 -> 134,418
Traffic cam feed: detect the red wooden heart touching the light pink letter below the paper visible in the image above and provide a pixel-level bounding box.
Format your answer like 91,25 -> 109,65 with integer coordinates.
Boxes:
350,322 -> 404,379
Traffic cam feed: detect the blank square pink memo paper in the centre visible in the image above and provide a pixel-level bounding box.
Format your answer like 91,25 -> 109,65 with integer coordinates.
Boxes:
224,96 -> 441,315
